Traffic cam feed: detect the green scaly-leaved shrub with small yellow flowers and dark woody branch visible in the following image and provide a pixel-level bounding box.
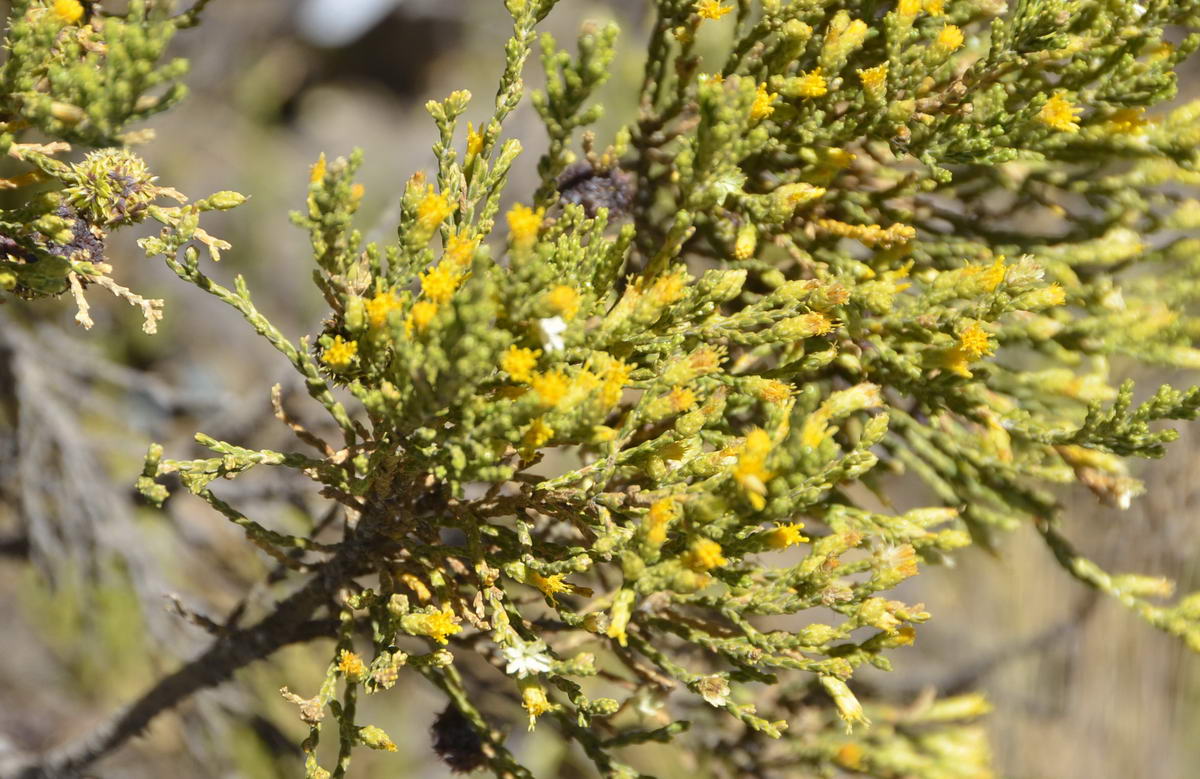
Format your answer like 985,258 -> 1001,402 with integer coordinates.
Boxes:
7,0 -> 1200,778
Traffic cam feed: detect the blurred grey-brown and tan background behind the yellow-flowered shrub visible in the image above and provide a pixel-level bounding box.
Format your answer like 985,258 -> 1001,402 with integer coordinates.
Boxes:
0,0 -> 1200,779
